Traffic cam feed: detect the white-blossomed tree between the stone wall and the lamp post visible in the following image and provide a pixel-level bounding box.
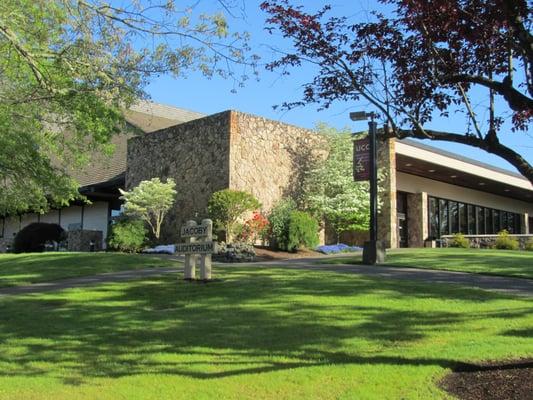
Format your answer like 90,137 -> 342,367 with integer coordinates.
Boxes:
304,124 -> 370,242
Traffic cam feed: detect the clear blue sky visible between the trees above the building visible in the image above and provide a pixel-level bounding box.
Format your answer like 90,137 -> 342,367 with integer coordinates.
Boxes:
147,0 -> 533,174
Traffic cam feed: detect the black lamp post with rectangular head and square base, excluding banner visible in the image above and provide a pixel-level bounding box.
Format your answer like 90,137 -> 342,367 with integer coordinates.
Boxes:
350,111 -> 385,265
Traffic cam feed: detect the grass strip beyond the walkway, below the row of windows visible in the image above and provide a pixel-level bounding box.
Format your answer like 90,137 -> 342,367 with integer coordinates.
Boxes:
321,248 -> 533,279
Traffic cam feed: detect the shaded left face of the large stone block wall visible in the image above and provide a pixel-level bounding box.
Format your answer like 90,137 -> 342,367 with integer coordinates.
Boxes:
126,111 -> 231,242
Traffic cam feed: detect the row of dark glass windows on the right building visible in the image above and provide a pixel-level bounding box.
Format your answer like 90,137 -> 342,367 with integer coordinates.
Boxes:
428,197 -> 521,239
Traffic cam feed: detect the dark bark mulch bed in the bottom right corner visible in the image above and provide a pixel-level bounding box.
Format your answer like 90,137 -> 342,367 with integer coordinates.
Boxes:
440,358 -> 533,400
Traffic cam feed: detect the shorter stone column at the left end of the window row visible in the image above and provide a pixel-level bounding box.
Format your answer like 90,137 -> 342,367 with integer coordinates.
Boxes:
407,192 -> 428,247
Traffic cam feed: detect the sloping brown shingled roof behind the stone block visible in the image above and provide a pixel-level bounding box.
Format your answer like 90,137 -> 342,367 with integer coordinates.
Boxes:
71,101 -> 205,188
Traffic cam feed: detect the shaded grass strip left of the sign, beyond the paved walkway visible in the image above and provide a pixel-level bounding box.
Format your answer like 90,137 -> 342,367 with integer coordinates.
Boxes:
0,253 -> 176,287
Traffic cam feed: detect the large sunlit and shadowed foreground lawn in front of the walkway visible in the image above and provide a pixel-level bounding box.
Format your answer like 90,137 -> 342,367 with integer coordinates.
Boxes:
0,267 -> 533,400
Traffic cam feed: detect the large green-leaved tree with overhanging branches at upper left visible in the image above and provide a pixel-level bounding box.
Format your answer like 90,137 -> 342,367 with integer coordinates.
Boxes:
0,0 -> 255,214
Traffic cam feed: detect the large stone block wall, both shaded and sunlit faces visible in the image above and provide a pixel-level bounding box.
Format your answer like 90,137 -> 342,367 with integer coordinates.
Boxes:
126,111 -> 325,242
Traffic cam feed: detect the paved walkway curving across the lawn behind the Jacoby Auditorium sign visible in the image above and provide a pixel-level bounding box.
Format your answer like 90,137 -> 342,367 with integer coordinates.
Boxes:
0,256 -> 533,297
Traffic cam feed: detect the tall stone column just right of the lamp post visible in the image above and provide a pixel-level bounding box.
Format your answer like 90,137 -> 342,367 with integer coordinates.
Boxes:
378,139 -> 398,249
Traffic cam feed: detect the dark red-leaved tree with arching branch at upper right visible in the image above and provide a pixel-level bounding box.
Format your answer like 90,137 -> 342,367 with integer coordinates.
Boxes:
261,0 -> 533,183
